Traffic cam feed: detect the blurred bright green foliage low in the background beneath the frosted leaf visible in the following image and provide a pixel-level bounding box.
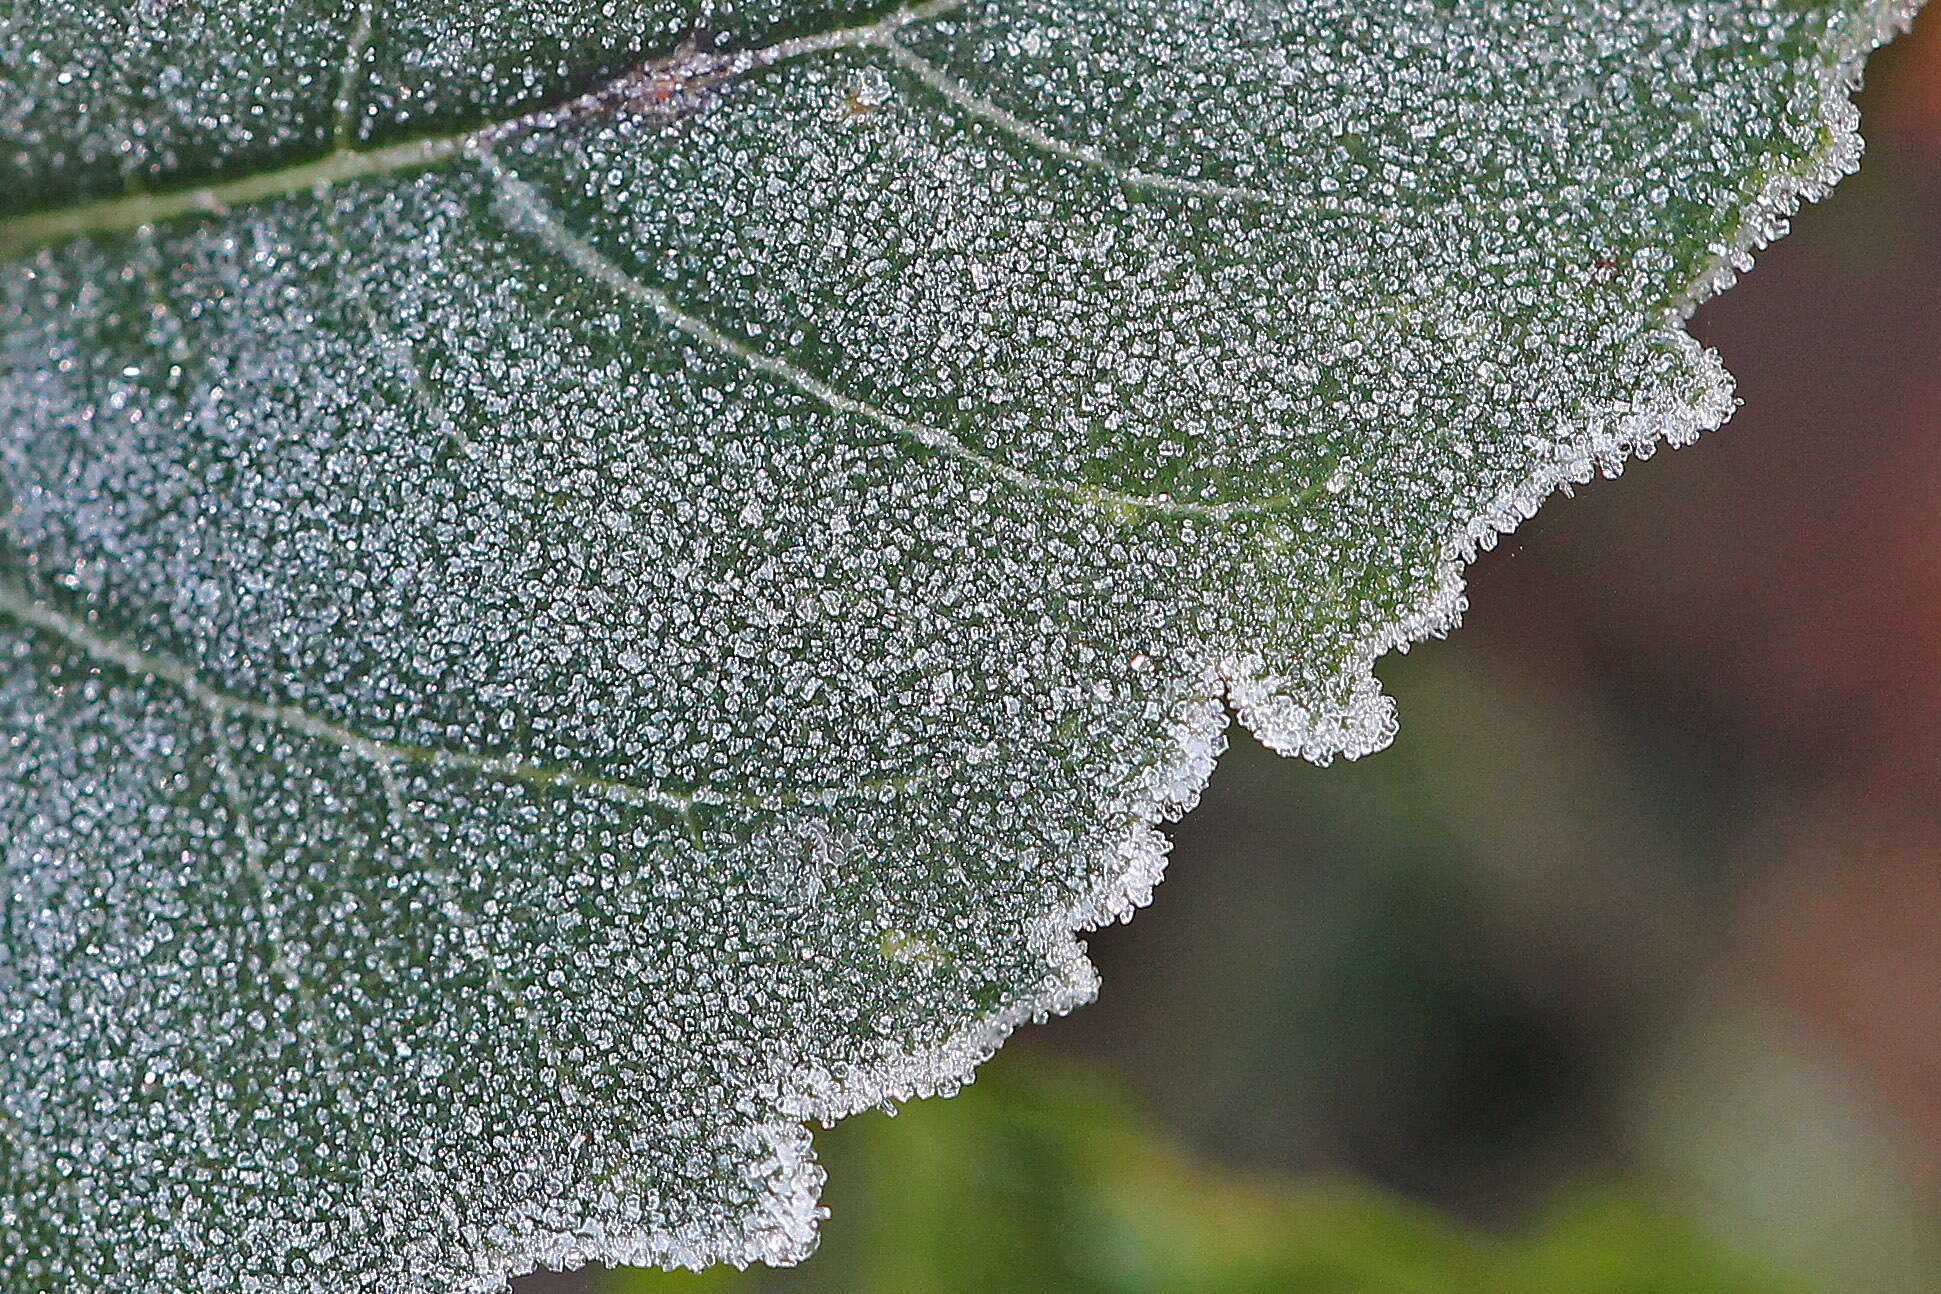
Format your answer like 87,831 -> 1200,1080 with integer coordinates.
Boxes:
606,1048 -> 1807,1294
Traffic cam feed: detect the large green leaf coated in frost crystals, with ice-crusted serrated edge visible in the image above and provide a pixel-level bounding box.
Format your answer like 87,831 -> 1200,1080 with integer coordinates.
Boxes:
0,0 -> 1906,1290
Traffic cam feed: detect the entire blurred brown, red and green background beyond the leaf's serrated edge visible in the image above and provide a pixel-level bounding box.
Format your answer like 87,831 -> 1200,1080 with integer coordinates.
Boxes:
514,12 -> 1941,1294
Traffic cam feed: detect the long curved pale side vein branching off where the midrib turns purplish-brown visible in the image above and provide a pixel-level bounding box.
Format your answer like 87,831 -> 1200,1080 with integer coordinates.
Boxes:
468,144 -> 1304,520
